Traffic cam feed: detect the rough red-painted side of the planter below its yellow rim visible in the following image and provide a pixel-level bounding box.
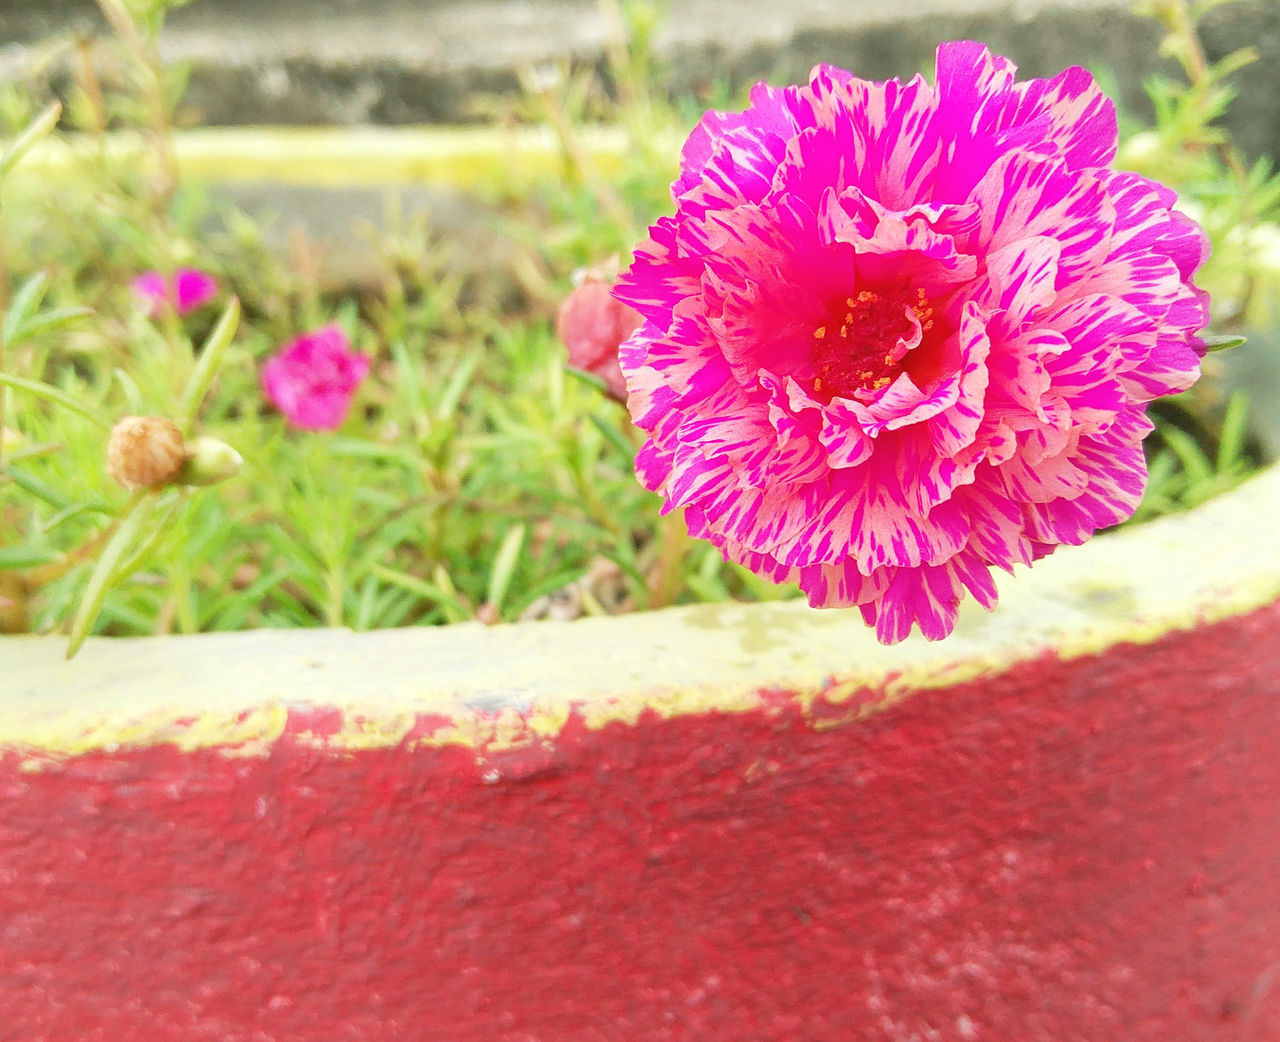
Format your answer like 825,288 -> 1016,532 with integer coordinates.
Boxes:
0,605 -> 1280,1042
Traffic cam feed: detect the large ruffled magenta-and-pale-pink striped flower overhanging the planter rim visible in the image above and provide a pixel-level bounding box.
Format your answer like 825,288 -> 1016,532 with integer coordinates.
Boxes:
614,42 -> 1207,643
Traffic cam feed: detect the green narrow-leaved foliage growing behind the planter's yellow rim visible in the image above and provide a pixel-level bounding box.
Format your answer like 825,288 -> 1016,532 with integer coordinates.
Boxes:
0,0 -> 1280,646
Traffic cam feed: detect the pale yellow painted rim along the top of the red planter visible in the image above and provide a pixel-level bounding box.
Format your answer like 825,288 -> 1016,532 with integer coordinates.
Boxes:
0,467 -> 1280,759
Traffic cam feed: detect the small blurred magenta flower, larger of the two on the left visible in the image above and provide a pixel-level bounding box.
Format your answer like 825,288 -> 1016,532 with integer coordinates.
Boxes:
262,325 -> 369,430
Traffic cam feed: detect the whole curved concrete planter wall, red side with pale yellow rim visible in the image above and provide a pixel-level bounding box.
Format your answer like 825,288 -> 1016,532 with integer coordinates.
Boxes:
0,467 -> 1280,1042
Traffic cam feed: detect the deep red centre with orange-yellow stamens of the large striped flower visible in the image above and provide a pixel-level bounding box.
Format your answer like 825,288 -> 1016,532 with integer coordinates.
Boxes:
812,289 -> 933,402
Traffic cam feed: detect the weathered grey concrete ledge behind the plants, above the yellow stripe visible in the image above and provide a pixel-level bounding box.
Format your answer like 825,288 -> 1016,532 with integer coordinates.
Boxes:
0,0 -> 1280,163
